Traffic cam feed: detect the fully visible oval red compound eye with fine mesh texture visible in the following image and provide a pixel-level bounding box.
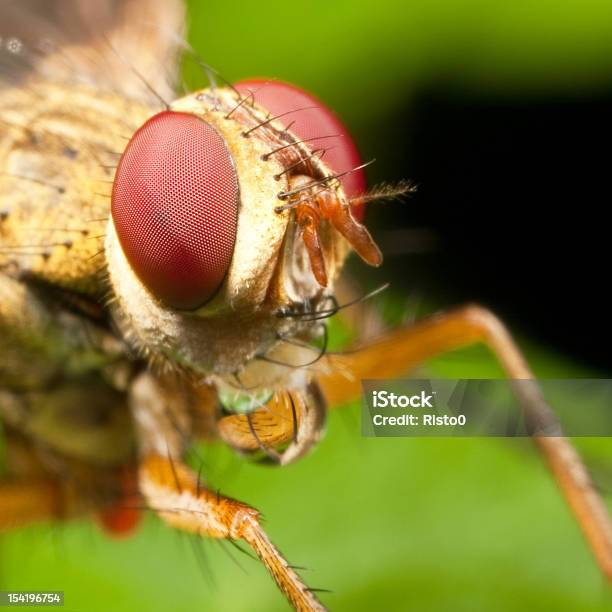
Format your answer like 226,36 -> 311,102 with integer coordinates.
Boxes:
112,111 -> 239,309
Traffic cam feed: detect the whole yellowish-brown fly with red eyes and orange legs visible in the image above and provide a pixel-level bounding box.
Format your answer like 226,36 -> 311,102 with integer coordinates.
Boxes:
0,0 -> 612,610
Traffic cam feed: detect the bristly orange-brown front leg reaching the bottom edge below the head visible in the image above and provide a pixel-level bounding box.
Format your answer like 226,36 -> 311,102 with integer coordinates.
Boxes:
131,373 -> 325,611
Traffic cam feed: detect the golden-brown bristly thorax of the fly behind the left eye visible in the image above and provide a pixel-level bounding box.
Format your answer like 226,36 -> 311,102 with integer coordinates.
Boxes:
0,80 -> 152,297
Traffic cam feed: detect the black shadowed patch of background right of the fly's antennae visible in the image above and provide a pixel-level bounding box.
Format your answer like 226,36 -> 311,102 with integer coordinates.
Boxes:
364,88 -> 612,370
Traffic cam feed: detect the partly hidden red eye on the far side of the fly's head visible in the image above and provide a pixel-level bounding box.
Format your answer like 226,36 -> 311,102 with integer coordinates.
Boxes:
236,79 -> 366,221
